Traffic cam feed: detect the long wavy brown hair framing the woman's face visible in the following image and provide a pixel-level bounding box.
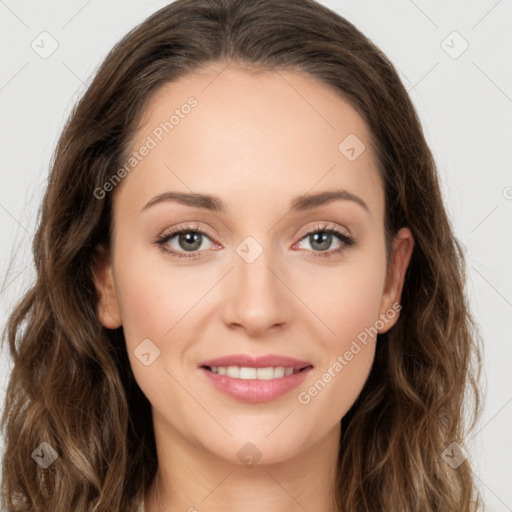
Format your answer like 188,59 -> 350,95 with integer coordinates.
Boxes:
2,0 -> 482,512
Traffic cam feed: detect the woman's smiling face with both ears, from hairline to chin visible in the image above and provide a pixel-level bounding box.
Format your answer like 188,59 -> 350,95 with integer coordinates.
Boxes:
92,63 -> 412,463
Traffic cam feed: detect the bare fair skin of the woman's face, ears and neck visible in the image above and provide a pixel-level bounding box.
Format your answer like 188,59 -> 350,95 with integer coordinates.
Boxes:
91,66 -> 414,512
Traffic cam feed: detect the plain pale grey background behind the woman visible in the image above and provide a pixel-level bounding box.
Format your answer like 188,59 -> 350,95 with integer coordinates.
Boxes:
0,0 -> 512,512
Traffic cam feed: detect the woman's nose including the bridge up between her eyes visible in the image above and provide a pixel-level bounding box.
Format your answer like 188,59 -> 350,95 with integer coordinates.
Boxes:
224,236 -> 291,334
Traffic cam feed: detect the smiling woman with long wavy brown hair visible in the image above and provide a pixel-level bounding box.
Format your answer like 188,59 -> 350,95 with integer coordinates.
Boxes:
3,0 -> 480,512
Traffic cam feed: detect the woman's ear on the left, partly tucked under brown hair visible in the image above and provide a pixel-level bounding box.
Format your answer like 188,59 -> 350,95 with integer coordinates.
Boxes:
93,245 -> 122,329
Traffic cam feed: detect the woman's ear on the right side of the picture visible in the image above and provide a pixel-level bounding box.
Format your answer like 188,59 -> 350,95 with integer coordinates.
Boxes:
379,228 -> 414,334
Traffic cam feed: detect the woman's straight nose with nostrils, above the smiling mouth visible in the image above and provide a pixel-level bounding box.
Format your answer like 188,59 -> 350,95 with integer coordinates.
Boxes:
222,242 -> 297,337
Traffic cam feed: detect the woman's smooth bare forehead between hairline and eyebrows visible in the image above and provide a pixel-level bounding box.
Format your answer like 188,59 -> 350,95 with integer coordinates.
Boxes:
116,66 -> 382,216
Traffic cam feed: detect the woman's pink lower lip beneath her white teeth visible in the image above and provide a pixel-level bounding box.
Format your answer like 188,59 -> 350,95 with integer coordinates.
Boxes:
199,366 -> 313,403
